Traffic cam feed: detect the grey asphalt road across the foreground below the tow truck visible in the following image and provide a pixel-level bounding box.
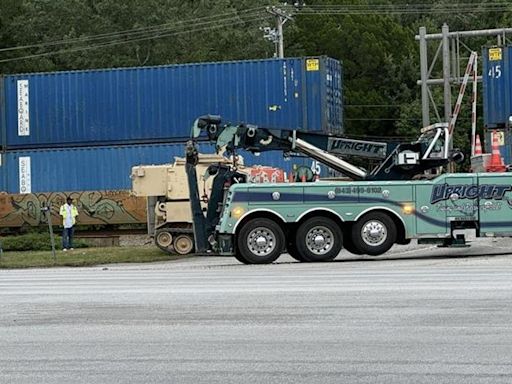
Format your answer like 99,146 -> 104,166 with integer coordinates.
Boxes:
0,240 -> 512,384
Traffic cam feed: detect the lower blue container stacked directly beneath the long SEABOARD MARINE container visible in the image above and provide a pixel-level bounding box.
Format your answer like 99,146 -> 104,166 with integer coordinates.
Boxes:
0,143 -> 311,193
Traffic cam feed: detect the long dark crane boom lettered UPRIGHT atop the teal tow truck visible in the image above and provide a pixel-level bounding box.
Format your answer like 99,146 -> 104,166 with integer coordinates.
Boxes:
192,115 -> 460,180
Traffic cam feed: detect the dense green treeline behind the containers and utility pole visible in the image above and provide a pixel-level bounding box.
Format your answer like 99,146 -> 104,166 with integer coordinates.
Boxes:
0,0 -> 512,142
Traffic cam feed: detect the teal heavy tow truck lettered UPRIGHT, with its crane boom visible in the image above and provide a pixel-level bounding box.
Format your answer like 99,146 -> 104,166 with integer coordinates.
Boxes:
187,115 -> 512,264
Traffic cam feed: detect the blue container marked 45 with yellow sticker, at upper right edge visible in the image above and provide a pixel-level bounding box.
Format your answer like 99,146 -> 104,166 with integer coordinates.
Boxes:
482,46 -> 512,128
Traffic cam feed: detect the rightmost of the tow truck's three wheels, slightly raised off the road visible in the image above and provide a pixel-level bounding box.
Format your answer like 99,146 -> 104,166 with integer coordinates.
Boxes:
351,212 -> 397,256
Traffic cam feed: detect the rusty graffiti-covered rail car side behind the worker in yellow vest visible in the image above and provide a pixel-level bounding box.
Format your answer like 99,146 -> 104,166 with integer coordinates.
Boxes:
0,191 -> 146,227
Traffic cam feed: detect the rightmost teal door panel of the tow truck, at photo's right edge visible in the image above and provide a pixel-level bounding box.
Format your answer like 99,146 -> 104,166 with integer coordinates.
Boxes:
478,173 -> 512,236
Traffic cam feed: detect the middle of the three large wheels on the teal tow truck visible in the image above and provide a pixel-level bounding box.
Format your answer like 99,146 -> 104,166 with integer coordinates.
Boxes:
295,217 -> 343,262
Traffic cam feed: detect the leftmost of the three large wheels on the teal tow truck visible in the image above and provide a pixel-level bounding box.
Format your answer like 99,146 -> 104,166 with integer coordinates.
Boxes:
236,218 -> 284,264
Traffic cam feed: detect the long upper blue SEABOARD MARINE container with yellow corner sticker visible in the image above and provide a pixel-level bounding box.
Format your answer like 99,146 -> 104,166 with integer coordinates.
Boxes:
0,56 -> 343,150
